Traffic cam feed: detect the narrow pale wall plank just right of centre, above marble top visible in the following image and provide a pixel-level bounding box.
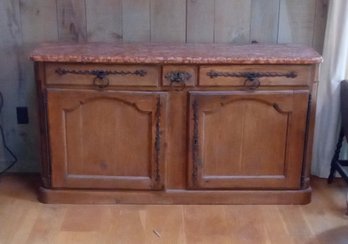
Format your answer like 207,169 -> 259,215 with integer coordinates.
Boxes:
186,0 -> 214,42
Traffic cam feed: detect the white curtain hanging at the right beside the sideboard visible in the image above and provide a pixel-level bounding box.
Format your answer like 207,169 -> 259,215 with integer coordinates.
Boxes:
312,0 -> 348,177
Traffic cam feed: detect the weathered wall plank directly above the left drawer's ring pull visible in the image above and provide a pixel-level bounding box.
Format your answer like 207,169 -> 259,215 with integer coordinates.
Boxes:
86,0 -> 122,42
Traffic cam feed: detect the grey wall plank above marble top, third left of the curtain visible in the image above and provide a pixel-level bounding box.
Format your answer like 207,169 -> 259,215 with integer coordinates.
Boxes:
250,0 -> 280,43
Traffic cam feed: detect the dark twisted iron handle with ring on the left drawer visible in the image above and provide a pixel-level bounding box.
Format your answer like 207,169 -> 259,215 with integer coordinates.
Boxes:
55,68 -> 147,88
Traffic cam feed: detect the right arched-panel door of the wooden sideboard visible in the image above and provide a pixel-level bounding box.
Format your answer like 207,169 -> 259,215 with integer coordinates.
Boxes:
188,91 -> 308,189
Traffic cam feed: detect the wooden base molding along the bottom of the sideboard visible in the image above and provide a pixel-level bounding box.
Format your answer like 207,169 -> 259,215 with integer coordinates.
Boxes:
39,187 -> 312,204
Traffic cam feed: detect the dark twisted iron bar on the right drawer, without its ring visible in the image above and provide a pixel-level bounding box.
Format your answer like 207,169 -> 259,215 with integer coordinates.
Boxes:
207,71 -> 297,80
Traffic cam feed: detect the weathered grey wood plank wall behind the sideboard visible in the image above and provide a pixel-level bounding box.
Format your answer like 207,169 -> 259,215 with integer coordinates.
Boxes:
0,0 -> 329,171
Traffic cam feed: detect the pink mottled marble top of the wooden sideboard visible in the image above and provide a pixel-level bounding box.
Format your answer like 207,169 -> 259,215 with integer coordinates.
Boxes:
30,43 -> 322,64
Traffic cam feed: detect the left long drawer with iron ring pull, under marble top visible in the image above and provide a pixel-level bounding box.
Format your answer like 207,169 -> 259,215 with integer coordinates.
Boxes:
46,63 -> 160,88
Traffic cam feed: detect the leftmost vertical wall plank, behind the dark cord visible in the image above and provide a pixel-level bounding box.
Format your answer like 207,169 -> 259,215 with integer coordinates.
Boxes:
0,0 -> 22,166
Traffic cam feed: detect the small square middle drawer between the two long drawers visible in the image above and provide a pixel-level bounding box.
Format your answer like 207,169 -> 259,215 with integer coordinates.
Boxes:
162,65 -> 197,87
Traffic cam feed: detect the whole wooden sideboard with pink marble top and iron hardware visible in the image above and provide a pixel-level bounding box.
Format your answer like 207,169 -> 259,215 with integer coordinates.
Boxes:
31,43 -> 321,204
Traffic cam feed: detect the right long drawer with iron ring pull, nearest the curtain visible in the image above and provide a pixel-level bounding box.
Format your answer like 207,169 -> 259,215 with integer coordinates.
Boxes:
199,65 -> 313,88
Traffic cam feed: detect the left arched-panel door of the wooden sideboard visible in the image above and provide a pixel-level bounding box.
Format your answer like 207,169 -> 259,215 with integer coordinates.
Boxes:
47,89 -> 166,189
